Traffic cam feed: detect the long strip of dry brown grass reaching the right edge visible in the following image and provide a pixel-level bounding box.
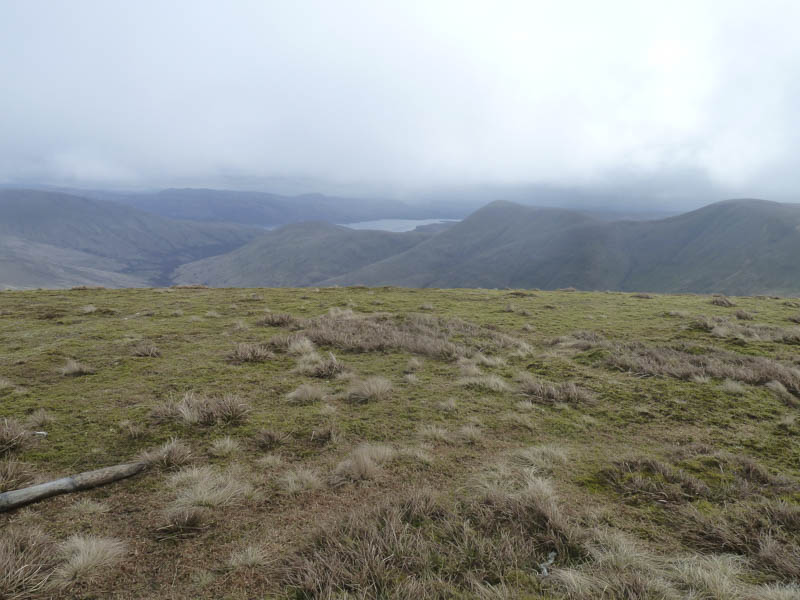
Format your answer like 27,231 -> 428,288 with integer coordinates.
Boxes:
606,342 -> 800,394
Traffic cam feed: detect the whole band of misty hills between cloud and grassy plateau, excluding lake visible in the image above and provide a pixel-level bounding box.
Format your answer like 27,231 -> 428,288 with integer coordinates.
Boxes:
0,184 -> 800,295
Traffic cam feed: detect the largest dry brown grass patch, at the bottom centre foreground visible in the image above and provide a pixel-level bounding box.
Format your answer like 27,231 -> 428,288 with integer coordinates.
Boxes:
279,464 -> 583,598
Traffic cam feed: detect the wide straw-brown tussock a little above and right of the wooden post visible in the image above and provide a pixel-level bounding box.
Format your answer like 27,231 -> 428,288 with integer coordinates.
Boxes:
151,392 -> 250,425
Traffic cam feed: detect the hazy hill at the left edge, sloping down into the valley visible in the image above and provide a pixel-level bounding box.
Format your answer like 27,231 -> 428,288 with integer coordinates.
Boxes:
0,190 -> 259,287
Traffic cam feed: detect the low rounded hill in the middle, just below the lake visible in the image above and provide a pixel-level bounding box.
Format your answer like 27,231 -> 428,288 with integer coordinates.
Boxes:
174,223 -> 431,287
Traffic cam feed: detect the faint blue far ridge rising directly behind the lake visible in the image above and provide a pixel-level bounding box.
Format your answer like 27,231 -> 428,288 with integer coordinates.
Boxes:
98,188 -> 460,226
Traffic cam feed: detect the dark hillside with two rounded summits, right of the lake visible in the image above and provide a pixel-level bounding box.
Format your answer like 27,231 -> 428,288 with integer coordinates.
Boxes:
325,200 -> 800,294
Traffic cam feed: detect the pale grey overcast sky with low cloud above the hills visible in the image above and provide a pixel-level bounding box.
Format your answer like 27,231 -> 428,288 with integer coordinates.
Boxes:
0,0 -> 800,200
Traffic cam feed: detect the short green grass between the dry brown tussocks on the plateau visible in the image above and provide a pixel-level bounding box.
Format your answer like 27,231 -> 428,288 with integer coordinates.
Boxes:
0,288 -> 800,598
